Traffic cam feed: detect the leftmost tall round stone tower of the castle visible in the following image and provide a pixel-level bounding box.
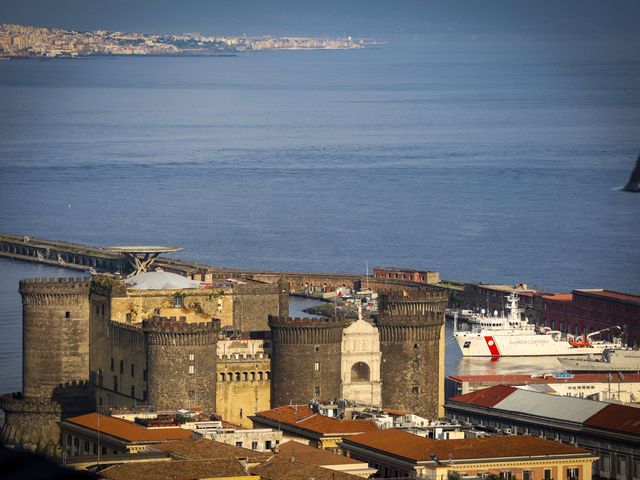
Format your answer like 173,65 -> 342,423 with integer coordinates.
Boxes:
19,278 -> 91,398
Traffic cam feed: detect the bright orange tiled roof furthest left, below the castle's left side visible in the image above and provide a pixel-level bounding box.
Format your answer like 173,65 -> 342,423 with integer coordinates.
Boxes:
66,412 -> 192,442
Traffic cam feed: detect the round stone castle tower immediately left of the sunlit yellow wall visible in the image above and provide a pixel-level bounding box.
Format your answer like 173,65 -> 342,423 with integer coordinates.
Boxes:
142,317 -> 220,413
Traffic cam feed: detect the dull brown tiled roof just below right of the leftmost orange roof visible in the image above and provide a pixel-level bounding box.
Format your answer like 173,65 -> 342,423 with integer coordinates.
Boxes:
153,438 -> 272,463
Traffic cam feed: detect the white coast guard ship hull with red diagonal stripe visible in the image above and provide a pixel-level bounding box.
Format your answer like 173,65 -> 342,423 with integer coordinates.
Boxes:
454,330 -> 619,357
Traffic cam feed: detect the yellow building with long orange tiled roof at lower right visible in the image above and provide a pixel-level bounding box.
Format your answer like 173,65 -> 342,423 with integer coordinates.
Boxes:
339,429 -> 598,480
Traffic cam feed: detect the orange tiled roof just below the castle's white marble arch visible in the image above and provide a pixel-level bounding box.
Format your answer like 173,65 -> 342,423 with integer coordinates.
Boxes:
255,405 -> 378,435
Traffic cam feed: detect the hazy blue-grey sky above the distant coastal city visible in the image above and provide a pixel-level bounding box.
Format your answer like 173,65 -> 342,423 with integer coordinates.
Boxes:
0,0 -> 640,36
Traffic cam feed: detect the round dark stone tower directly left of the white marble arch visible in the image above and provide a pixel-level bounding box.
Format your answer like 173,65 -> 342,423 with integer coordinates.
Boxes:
269,316 -> 345,408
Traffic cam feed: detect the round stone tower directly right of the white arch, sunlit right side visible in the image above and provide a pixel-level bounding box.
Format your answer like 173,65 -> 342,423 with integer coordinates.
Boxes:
376,288 -> 448,419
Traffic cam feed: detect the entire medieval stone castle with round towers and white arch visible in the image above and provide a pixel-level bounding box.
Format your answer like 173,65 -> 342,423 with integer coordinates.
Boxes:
0,272 -> 447,454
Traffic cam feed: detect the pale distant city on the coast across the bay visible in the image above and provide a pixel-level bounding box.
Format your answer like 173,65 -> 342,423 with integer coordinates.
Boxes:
0,24 -> 365,57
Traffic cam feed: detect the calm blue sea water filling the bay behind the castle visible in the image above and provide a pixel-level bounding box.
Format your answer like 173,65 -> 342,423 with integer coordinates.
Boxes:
0,33 -> 640,392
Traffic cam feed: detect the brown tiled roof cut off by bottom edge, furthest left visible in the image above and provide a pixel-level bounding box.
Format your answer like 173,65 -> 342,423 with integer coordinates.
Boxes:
99,459 -> 251,480
